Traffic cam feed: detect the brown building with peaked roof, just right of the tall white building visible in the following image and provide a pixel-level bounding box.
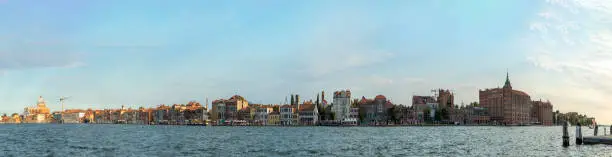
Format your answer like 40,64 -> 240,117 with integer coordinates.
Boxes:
357,95 -> 393,125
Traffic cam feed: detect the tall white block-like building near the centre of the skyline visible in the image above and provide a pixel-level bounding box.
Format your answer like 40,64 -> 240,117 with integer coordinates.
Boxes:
332,90 -> 351,120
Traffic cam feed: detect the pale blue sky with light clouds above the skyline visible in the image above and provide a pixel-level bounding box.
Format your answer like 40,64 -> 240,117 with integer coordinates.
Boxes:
0,0 -> 612,123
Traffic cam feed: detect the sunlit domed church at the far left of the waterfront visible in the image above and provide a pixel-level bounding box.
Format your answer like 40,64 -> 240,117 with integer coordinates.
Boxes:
23,96 -> 52,123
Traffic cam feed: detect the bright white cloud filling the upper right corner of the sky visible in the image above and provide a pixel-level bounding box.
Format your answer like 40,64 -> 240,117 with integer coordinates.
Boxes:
527,0 -> 612,120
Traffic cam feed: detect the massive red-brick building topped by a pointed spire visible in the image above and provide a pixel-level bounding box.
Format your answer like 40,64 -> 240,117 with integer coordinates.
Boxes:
479,72 -> 531,125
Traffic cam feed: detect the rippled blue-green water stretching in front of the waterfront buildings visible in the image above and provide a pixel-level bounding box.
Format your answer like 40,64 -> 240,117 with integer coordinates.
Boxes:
0,125 -> 612,156
